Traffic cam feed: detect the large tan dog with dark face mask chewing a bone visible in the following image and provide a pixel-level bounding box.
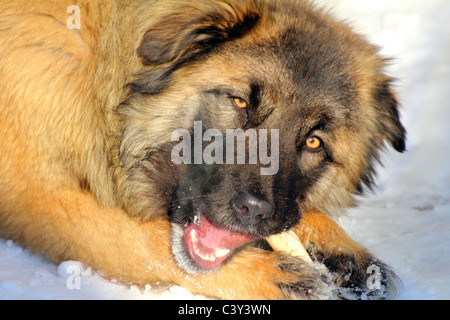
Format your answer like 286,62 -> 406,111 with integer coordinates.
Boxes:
0,0 -> 405,299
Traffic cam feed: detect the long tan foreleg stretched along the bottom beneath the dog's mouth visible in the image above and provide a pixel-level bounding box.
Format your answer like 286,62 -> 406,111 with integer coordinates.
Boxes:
0,190 -> 330,299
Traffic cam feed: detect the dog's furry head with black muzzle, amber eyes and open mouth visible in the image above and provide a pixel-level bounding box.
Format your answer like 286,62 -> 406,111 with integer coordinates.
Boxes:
121,1 -> 405,273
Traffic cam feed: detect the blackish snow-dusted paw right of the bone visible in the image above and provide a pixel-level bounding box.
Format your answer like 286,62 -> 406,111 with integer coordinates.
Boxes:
311,246 -> 400,300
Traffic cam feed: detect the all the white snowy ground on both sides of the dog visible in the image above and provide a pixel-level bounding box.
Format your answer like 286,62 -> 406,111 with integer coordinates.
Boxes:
0,0 -> 450,299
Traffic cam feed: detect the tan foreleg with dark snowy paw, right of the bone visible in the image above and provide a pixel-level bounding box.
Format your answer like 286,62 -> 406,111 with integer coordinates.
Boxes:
295,212 -> 398,299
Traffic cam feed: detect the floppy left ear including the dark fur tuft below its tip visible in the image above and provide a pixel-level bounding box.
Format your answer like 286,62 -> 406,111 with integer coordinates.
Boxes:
129,0 -> 260,95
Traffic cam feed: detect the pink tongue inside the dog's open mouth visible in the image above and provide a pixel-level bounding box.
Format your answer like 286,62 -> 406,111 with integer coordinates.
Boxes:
198,217 -> 257,250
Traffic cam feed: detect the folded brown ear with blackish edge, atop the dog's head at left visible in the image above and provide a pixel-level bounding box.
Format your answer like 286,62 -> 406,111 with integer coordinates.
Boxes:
137,1 -> 259,65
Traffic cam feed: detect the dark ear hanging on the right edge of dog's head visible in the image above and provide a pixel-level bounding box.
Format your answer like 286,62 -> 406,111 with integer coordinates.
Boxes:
375,80 -> 406,152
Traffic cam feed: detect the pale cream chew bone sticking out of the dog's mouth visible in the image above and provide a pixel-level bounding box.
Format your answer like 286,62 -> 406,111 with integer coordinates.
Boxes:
266,230 -> 312,263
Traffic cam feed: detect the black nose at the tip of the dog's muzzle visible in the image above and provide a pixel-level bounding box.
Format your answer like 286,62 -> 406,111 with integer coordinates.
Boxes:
233,192 -> 273,225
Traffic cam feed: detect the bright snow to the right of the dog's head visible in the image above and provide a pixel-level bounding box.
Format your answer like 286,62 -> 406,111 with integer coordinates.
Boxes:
320,0 -> 450,299
